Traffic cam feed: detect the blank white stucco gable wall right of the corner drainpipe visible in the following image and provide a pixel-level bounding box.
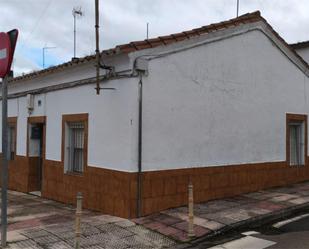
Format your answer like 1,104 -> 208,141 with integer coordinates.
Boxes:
143,28 -> 309,170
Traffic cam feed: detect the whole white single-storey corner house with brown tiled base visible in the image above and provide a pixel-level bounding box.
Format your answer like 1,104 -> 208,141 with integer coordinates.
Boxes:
0,12 -> 309,217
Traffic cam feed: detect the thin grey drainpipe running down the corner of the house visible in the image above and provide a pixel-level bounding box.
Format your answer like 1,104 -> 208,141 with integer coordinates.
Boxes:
136,72 -> 143,217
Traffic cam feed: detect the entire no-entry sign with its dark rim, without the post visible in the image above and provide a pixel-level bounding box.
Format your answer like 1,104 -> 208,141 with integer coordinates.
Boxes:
0,29 -> 18,78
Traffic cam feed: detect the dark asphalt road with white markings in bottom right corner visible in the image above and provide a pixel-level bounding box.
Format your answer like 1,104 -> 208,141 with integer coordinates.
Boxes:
183,214 -> 309,249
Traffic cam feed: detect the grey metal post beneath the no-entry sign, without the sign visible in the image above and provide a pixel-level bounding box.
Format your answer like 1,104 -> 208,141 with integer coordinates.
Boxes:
1,76 -> 8,248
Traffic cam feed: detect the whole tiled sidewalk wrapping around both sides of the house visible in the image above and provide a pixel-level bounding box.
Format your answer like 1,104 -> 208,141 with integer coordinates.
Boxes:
1,182 -> 309,249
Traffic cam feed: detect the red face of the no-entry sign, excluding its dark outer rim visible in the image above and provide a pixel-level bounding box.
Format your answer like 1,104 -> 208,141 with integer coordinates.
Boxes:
0,32 -> 12,78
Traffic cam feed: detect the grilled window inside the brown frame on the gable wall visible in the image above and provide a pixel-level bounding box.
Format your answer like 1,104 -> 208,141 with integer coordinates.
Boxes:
289,122 -> 305,165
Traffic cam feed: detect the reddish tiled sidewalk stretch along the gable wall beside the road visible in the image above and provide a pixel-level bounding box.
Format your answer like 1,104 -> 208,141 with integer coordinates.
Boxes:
133,182 -> 309,242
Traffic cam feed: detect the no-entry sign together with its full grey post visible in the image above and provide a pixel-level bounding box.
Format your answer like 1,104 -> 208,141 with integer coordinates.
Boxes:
0,29 -> 18,248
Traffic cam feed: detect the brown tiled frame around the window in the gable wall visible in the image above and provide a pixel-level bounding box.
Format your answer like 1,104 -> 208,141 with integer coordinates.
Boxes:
286,113 -> 308,167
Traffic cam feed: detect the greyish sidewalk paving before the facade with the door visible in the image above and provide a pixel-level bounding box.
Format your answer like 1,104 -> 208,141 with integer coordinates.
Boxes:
0,191 -> 176,249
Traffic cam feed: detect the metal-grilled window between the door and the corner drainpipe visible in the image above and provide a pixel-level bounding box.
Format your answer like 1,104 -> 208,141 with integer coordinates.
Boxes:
67,122 -> 84,173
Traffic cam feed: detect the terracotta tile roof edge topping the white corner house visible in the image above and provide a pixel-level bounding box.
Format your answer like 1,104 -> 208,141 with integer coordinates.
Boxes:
11,11 -> 308,81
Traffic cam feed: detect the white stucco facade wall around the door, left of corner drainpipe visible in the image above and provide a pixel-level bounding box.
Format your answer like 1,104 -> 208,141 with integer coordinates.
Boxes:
0,78 -> 138,171
